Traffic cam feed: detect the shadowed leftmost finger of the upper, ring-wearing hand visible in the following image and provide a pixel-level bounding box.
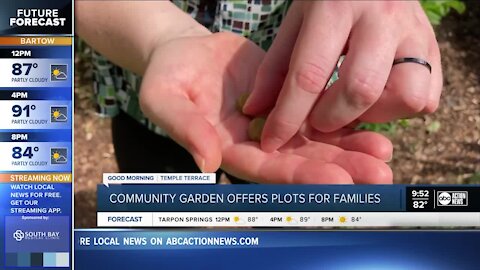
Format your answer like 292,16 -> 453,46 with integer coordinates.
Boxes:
243,2 -> 302,115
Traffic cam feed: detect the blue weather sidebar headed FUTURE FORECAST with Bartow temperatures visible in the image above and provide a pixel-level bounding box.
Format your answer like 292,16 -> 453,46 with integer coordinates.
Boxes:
0,0 -> 73,269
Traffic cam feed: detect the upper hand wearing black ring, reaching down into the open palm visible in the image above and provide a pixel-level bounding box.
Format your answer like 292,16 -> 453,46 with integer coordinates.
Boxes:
244,1 -> 442,152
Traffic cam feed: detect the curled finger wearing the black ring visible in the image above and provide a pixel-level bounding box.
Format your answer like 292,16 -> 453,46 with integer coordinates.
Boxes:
360,38 -> 431,123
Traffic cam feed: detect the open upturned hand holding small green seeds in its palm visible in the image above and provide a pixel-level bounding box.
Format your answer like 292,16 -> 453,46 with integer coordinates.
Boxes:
140,33 -> 392,184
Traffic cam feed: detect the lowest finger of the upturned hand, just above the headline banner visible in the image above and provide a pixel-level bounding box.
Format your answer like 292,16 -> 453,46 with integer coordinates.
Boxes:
222,142 -> 353,184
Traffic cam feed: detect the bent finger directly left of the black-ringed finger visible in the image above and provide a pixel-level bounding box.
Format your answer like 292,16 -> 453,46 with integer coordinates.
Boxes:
310,19 -> 397,132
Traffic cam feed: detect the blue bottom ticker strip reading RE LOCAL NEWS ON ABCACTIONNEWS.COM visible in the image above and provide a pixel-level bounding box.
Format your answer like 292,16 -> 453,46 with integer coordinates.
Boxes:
75,229 -> 480,270
